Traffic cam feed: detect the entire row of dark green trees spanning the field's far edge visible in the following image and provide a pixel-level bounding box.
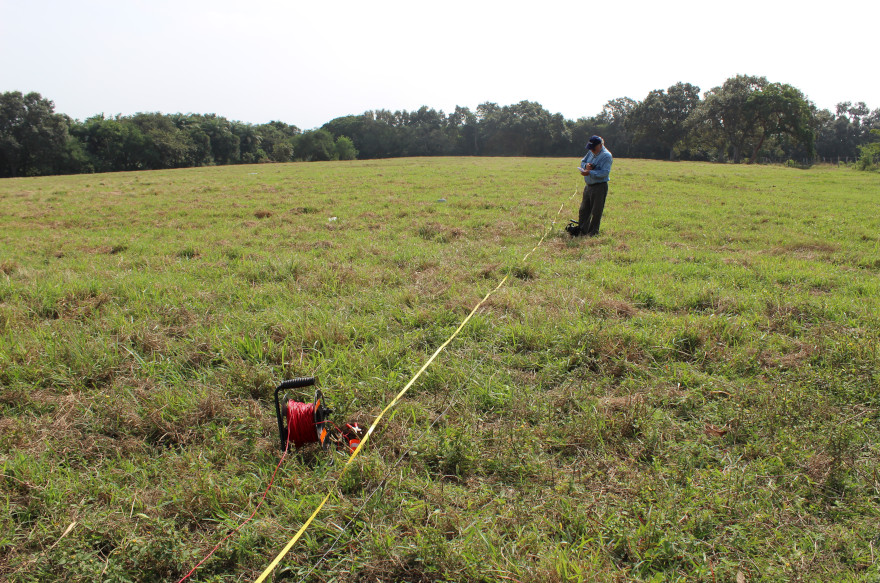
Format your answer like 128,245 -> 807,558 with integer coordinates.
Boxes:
0,75 -> 880,176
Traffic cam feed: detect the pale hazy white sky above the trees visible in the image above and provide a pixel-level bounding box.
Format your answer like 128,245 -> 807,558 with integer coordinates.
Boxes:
0,0 -> 880,130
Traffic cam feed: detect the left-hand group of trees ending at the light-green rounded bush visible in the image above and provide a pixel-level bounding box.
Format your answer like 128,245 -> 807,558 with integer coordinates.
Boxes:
0,92 -> 357,177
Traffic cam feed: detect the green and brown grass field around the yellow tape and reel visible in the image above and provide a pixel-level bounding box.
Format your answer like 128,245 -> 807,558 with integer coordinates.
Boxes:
0,158 -> 880,583
